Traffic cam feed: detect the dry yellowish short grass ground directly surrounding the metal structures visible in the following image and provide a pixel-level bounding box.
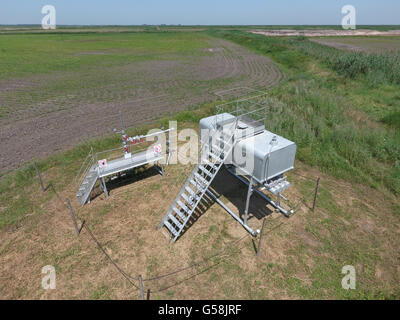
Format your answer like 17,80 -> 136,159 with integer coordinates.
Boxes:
0,105 -> 400,299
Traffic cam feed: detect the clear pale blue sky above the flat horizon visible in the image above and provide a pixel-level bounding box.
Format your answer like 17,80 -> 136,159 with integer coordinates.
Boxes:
0,0 -> 400,25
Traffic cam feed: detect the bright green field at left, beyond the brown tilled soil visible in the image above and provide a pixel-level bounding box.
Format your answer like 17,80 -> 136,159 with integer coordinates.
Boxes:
0,32 -> 206,79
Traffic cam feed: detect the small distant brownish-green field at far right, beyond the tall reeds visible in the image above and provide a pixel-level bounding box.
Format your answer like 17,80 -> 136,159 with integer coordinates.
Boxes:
311,37 -> 400,53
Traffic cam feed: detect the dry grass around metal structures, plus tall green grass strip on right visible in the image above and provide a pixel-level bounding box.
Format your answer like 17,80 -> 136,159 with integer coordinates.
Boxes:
0,28 -> 400,299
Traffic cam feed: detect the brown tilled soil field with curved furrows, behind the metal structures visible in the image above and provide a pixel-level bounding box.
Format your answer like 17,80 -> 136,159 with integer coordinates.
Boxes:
0,37 -> 284,172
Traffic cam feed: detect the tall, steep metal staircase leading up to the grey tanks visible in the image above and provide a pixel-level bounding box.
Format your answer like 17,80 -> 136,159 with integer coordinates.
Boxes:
158,120 -> 237,242
